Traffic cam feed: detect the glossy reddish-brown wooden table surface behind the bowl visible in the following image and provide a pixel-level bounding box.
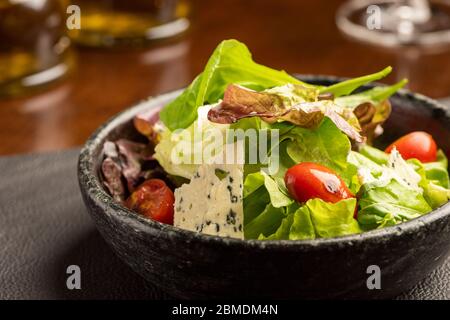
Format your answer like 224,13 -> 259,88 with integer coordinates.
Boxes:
0,0 -> 450,155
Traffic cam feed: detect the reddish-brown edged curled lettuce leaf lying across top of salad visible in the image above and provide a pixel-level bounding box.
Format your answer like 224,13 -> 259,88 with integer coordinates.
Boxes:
208,84 -> 364,142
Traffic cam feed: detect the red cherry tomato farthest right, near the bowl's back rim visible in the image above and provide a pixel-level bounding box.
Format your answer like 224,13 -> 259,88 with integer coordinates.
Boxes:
385,131 -> 437,162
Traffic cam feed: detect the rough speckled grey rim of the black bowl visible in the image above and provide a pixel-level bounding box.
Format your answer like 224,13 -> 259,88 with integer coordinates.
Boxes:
78,75 -> 450,249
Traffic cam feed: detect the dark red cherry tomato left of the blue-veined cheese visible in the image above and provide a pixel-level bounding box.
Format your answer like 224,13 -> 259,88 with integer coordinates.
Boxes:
125,179 -> 175,224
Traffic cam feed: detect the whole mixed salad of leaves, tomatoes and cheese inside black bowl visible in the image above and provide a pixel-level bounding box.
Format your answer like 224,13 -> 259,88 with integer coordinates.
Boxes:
101,40 -> 450,240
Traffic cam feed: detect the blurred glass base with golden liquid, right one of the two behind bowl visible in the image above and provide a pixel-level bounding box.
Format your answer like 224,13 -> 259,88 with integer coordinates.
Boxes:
70,0 -> 190,47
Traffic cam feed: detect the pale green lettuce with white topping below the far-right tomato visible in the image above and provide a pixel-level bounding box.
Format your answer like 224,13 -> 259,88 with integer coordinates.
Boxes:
349,145 -> 450,229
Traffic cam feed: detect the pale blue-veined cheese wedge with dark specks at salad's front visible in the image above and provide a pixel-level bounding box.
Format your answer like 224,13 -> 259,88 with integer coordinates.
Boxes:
174,164 -> 244,239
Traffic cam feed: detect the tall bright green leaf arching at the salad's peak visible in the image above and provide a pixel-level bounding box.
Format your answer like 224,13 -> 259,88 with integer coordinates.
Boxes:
160,40 -> 312,131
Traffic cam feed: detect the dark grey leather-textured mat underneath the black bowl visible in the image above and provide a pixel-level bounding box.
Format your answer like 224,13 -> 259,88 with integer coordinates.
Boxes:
0,150 -> 450,299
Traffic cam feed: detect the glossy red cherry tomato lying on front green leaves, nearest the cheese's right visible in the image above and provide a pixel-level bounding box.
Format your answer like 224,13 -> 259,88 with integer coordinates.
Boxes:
284,162 -> 355,203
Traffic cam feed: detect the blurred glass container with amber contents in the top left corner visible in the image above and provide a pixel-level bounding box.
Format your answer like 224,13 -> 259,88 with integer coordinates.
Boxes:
0,0 -> 73,97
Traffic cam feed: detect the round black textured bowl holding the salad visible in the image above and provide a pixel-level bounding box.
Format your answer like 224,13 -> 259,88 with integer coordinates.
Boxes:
78,77 -> 450,299
